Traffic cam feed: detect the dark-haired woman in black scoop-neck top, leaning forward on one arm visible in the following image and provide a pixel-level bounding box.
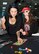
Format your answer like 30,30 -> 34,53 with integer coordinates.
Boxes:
2,3 -> 22,42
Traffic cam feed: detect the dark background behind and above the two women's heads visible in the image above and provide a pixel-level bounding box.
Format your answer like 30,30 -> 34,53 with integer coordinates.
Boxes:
0,0 -> 39,18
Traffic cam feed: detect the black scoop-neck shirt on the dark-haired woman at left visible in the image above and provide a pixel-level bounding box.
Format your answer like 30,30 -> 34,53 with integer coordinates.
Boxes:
5,15 -> 22,35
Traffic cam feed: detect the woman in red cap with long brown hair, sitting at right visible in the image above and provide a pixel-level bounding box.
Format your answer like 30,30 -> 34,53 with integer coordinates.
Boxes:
20,7 -> 38,36
